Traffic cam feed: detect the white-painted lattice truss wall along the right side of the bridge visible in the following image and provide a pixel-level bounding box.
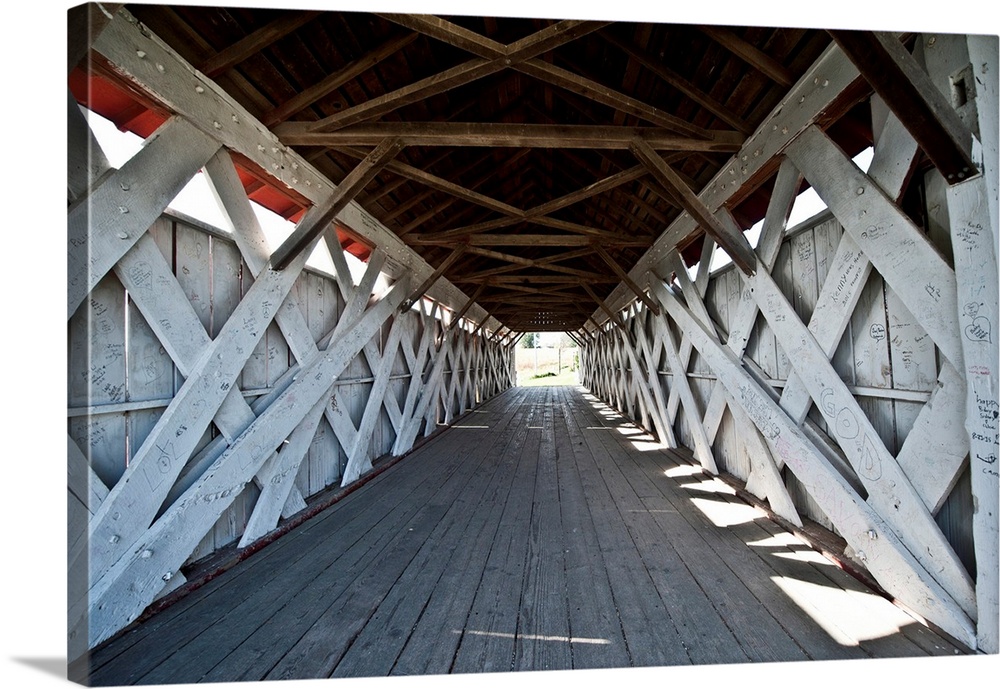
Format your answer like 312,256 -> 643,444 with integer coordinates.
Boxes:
578,37 -> 998,653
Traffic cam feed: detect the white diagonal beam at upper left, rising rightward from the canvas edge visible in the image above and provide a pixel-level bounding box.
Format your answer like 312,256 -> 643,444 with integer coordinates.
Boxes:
67,117 -> 219,317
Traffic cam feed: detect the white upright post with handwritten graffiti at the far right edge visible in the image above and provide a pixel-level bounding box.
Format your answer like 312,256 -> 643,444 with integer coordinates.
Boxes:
922,34 -> 1000,653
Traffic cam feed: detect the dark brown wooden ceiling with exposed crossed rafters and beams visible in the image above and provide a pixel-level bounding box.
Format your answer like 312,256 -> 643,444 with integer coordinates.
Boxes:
117,5 -> 848,331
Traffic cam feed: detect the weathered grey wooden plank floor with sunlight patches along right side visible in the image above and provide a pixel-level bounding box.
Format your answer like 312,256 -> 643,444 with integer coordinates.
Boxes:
84,387 -> 963,686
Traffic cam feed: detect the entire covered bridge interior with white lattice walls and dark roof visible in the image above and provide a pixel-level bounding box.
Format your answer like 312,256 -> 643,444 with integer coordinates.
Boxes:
67,3 -> 1000,684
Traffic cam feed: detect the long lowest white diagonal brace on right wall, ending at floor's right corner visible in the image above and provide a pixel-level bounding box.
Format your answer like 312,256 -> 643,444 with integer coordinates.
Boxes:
654,273 -> 975,644
